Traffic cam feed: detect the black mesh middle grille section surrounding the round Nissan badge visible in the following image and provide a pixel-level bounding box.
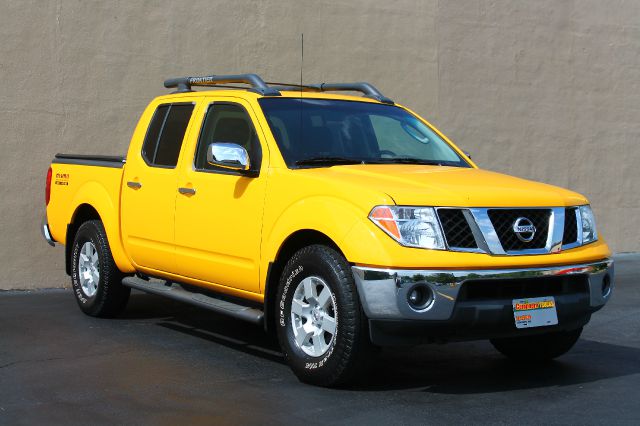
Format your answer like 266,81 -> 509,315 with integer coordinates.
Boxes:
487,209 -> 551,251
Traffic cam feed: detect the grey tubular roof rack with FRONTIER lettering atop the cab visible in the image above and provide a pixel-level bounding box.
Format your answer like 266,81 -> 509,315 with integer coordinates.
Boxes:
164,74 -> 393,104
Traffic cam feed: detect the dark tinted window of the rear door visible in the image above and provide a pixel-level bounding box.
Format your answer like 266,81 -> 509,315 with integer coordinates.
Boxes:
142,104 -> 193,167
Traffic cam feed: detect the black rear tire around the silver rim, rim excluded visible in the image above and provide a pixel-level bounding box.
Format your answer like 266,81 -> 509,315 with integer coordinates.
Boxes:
71,220 -> 131,318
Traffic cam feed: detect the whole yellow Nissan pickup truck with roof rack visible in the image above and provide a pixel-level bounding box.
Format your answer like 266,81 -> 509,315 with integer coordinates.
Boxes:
42,74 -> 614,386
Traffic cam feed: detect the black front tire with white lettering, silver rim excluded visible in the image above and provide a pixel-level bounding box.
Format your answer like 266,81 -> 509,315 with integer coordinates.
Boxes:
275,245 -> 369,387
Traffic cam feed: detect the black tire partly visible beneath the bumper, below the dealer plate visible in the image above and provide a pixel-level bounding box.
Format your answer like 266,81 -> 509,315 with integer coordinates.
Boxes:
491,328 -> 582,362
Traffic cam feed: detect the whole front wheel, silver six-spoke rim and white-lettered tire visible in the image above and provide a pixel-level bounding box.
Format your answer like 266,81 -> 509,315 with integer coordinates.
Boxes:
276,245 -> 369,386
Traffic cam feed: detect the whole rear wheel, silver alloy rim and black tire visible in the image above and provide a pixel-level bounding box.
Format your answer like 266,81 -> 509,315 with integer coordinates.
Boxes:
71,220 -> 131,317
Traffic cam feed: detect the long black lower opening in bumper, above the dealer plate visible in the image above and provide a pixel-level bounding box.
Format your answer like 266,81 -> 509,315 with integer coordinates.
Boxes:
458,275 -> 589,300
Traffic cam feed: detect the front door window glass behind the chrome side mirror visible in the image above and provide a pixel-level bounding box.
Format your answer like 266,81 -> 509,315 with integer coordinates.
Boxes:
195,102 -> 262,173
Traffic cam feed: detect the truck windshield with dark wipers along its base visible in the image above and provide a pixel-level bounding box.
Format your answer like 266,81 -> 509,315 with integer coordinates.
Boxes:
259,98 -> 470,168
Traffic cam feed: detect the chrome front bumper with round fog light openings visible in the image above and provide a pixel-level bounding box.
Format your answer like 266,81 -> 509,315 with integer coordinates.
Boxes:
352,259 -> 614,321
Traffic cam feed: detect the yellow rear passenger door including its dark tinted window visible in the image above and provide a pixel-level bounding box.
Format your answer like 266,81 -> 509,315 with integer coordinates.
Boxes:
121,103 -> 195,272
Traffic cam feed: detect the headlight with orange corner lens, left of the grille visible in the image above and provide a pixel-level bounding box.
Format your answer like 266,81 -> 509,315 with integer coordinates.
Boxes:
369,206 -> 445,250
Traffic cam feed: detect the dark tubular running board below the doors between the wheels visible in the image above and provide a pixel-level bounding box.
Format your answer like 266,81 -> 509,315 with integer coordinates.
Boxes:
122,277 -> 264,325
